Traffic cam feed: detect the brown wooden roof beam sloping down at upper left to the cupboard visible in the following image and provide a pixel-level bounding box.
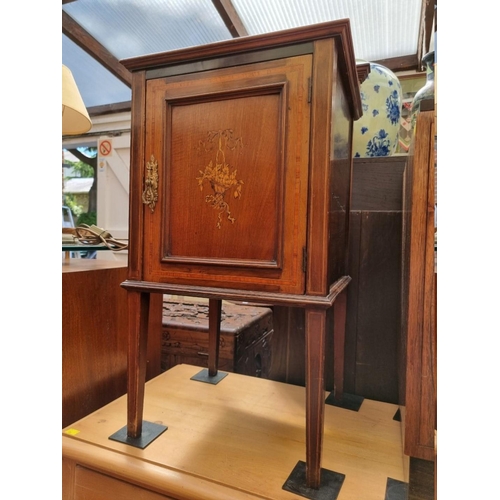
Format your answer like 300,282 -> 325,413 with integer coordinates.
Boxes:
62,10 -> 132,87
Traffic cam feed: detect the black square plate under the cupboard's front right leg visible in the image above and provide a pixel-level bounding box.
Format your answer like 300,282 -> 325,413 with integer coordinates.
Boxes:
283,460 -> 345,500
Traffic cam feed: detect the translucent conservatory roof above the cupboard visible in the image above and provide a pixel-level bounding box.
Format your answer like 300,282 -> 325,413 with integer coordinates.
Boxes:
62,0 -> 430,108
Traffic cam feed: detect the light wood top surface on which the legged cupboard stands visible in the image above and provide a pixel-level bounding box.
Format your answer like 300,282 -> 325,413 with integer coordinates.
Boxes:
63,365 -> 406,500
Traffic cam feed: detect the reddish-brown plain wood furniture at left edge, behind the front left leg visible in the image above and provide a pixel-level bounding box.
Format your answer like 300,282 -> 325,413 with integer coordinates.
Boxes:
62,259 -> 161,427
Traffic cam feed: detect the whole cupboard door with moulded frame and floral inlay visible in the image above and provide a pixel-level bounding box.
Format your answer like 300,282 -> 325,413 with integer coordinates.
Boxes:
143,55 -> 312,293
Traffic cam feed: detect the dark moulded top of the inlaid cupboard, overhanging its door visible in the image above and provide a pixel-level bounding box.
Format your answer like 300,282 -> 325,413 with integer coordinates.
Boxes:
120,19 -> 362,120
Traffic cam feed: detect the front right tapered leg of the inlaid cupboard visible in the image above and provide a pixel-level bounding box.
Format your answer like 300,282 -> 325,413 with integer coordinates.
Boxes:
305,310 -> 326,488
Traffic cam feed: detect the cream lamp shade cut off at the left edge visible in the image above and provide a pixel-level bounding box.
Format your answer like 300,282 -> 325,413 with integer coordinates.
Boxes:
62,65 -> 92,135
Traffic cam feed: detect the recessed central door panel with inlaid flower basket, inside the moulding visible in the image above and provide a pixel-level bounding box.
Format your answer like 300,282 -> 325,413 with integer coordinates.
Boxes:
167,92 -> 284,268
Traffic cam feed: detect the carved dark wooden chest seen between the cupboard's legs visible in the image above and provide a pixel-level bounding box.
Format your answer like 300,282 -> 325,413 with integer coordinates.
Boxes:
161,297 -> 273,378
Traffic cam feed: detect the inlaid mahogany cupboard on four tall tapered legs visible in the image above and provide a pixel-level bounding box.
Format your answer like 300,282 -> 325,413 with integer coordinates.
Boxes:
117,19 -> 362,489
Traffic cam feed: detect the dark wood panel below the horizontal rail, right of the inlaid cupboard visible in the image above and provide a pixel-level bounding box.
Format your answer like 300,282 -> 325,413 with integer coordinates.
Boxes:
355,212 -> 401,404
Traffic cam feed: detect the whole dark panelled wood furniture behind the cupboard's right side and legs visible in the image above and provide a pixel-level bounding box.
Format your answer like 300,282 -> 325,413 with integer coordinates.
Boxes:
271,156 -> 406,403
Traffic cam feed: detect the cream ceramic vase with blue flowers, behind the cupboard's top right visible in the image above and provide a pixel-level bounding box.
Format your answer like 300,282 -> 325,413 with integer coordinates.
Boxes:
352,61 -> 402,158
